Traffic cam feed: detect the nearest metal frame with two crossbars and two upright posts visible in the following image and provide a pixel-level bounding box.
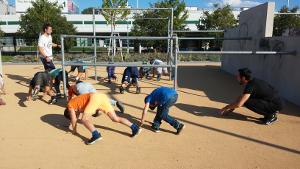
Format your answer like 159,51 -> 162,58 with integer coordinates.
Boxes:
60,35 -> 177,99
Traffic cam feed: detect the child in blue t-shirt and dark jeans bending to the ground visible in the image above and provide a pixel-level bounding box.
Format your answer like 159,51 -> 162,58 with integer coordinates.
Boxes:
141,87 -> 184,134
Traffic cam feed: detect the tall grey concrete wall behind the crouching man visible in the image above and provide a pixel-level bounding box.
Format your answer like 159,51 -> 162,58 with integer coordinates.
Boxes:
222,3 -> 300,105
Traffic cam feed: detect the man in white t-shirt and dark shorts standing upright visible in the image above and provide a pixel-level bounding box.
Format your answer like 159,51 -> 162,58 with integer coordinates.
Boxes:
38,23 -> 60,71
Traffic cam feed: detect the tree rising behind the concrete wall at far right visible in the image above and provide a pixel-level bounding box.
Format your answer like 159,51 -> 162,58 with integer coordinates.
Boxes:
273,6 -> 300,36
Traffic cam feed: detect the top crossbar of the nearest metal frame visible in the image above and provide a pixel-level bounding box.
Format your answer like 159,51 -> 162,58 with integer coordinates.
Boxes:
61,35 -> 175,40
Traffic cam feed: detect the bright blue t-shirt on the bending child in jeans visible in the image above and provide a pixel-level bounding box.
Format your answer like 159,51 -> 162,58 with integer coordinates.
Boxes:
145,87 -> 177,105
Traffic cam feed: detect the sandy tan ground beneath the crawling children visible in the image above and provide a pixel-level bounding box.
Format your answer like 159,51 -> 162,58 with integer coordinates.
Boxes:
0,64 -> 300,169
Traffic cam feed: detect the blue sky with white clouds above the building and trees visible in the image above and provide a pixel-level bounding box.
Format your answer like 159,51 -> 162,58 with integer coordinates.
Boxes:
9,0 -> 300,10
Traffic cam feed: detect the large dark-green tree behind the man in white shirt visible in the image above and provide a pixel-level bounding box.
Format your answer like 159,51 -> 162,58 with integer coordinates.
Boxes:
18,0 -> 76,50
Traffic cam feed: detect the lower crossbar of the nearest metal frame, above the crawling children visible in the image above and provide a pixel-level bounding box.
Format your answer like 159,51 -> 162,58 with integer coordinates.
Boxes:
64,61 -> 175,67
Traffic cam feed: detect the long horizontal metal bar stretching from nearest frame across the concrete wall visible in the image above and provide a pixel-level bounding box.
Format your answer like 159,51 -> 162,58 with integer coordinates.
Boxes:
178,51 -> 296,55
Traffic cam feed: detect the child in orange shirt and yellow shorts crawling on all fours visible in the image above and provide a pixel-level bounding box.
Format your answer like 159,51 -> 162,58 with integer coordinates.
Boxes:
64,93 -> 140,144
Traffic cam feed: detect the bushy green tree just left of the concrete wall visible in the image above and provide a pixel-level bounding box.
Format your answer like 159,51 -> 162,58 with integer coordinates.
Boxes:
197,4 -> 238,49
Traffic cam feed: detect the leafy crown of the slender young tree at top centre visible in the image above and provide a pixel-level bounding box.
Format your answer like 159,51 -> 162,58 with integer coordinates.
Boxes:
100,0 -> 130,30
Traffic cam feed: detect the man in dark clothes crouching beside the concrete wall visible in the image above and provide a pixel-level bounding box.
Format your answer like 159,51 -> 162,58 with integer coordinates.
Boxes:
220,68 -> 282,125
